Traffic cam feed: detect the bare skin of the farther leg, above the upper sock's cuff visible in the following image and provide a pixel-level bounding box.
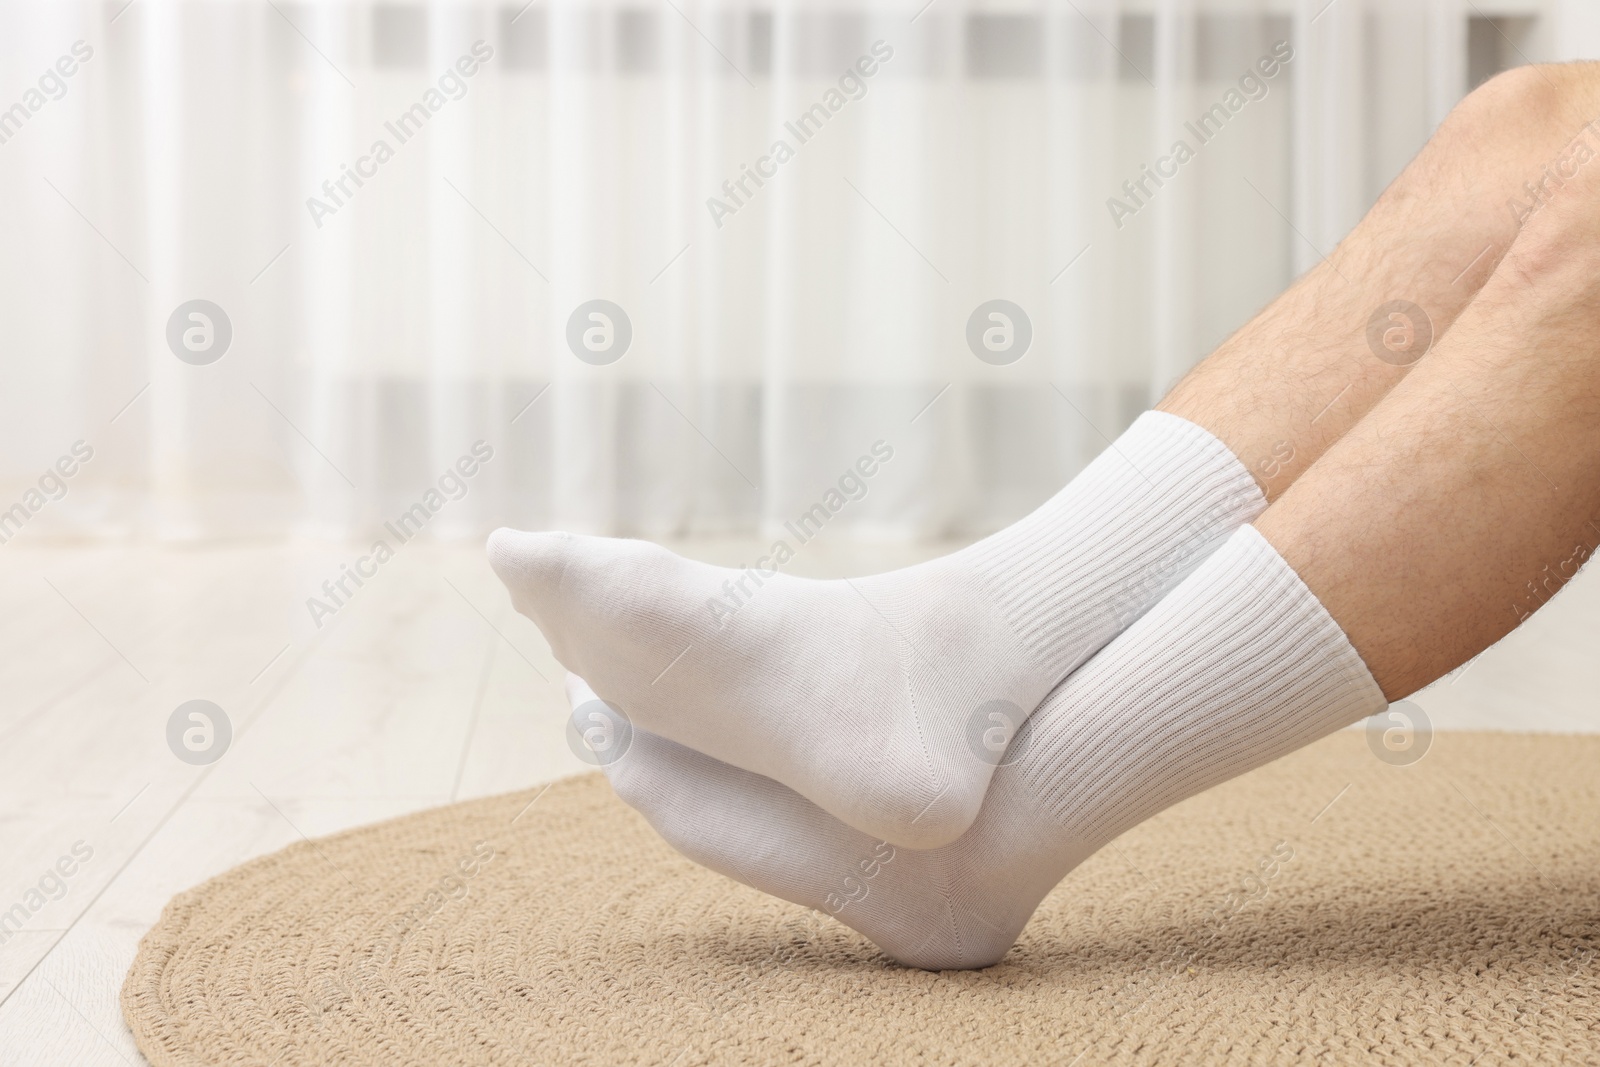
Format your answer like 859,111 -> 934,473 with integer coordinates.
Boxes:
1158,64 -> 1600,499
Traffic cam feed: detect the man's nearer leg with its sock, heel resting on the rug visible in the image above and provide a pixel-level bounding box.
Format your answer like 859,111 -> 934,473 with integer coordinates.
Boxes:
573,69 -> 1600,966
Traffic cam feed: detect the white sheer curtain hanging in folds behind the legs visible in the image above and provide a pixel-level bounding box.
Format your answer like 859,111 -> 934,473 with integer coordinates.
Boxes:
0,0 -> 1580,539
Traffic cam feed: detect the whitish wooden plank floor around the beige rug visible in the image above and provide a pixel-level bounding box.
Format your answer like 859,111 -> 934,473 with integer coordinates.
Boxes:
0,541 -> 1600,1067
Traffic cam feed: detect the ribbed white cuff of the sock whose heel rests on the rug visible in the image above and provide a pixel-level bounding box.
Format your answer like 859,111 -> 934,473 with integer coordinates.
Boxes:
1032,526 -> 1387,841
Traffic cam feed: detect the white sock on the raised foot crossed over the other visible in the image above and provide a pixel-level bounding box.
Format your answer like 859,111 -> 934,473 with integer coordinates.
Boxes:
488,411 -> 1264,848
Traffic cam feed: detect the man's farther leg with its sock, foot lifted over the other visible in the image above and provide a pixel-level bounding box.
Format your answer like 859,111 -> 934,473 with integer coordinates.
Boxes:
490,69 -> 1589,848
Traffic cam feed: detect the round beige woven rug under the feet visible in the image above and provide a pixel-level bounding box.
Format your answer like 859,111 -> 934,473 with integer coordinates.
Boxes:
122,733 -> 1600,1067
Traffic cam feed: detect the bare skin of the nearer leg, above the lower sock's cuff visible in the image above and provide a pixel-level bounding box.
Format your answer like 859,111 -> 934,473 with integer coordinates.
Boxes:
1256,67 -> 1600,699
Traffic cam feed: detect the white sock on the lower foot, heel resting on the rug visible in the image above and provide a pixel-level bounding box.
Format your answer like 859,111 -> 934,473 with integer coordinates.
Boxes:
568,526 -> 1386,969
